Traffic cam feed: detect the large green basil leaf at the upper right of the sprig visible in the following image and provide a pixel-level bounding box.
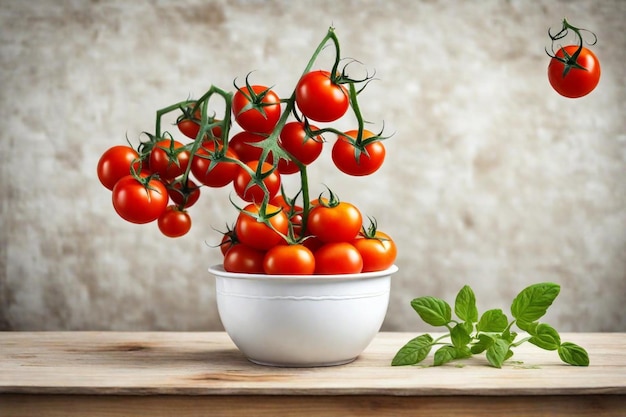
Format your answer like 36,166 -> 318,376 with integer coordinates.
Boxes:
511,282 -> 561,324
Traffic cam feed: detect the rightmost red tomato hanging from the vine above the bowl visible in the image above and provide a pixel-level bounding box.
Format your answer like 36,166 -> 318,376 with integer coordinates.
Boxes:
332,130 -> 386,176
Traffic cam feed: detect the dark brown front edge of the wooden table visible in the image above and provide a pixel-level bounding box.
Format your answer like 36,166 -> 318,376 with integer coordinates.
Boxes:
0,395 -> 626,417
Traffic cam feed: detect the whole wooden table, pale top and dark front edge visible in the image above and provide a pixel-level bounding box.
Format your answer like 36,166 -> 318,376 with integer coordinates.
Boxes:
0,332 -> 626,417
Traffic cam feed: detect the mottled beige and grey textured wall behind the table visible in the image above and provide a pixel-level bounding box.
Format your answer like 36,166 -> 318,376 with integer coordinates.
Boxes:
0,0 -> 626,331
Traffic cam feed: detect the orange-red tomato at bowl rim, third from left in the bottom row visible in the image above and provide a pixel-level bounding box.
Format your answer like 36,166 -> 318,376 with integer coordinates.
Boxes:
315,242 -> 363,274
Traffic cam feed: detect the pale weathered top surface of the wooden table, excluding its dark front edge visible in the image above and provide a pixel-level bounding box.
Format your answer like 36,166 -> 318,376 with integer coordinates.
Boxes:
0,332 -> 626,396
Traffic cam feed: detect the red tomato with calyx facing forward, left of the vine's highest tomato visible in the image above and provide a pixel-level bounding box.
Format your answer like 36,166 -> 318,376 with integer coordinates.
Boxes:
232,85 -> 281,133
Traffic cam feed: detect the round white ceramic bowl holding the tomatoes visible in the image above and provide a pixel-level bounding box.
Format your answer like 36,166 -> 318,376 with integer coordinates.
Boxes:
209,265 -> 398,367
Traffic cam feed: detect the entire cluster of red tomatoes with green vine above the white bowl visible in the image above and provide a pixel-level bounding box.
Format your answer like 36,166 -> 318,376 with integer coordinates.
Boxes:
97,28 -> 397,274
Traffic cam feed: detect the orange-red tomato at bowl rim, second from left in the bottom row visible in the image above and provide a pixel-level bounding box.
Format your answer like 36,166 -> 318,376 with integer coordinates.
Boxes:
263,245 -> 315,275
